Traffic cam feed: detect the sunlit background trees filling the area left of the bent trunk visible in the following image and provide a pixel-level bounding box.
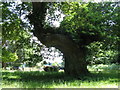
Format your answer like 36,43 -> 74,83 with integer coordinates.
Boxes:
1,2 -> 42,67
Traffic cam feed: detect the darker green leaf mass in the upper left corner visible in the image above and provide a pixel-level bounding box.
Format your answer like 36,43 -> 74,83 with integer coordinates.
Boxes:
2,3 -> 22,43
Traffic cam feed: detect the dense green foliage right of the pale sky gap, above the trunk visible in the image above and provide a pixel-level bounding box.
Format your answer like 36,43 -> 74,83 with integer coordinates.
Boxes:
55,2 -> 120,45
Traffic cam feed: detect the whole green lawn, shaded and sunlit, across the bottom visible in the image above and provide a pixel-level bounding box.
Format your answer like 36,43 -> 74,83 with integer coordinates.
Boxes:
2,71 -> 118,88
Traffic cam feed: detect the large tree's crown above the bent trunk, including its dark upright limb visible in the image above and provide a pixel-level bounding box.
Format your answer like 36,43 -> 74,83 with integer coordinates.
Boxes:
27,2 -> 119,45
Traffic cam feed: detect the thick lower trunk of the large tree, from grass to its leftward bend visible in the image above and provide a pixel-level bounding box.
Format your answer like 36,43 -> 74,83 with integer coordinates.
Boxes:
34,31 -> 88,76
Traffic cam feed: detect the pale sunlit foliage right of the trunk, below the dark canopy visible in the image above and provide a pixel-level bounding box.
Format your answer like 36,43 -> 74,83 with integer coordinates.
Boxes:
87,42 -> 118,64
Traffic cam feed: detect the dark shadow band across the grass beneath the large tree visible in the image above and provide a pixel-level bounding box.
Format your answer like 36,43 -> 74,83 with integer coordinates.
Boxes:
2,71 -> 118,88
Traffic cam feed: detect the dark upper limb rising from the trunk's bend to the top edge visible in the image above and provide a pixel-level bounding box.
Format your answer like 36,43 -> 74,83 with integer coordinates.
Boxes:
29,2 -> 77,50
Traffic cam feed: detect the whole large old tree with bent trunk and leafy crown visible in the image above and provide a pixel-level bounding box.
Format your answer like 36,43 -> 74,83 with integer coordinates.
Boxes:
28,2 -> 117,76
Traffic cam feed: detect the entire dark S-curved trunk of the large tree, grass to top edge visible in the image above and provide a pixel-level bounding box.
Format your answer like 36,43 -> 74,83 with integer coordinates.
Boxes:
29,2 -> 88,76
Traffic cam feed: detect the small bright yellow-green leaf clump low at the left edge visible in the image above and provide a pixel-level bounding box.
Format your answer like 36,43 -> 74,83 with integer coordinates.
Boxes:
2,49 -> 18,62
